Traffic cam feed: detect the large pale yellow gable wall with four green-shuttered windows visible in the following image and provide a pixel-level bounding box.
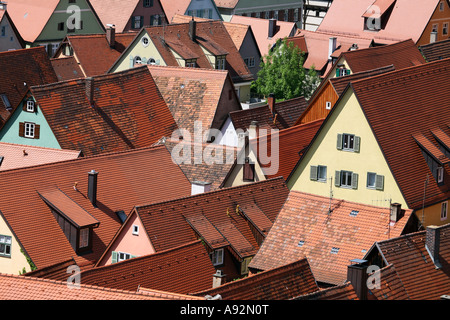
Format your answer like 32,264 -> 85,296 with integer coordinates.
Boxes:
288,88 -> 407,208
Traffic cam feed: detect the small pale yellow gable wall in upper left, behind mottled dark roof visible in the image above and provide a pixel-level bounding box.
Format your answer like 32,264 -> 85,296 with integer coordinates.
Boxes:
110,29 -> 167,72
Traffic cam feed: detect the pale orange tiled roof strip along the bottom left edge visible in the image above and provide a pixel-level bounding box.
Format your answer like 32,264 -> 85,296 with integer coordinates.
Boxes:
0,274 -> 197,301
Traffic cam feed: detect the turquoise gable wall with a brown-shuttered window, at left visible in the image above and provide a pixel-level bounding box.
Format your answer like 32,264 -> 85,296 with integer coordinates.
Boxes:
0,102 -> 61,149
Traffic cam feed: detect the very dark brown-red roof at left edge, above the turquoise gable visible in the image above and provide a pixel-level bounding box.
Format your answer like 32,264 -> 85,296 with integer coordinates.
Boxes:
0,47 -> 58,125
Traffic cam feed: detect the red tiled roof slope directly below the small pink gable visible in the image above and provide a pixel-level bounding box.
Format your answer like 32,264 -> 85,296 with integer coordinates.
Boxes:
81,240 -> 215,294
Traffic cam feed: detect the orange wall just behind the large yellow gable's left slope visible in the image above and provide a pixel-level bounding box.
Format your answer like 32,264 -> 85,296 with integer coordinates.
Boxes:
300,81 -> 339,124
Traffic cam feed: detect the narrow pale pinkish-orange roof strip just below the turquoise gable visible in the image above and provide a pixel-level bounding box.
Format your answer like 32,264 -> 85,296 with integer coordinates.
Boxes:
0,142 -> 81,171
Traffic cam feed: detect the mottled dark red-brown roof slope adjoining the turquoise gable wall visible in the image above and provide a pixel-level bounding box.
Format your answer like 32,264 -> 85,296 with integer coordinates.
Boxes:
31,67 -> 177,155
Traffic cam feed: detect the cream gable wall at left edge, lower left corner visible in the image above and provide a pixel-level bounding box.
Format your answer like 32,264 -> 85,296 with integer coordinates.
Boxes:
0,217 -> 31,274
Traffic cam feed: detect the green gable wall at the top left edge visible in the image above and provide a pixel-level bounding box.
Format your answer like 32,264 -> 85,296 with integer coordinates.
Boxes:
33,0 -> 104,53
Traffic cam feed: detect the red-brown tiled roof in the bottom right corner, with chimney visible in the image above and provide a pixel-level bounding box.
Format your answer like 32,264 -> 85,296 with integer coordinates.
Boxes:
368,224 -> 450,300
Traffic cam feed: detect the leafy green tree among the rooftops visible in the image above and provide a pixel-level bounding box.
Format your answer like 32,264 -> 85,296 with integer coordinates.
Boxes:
251,39 -> 320,100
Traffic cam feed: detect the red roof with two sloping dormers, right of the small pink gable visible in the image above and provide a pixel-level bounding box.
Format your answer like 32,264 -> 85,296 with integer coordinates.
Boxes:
135,178 -> 288,260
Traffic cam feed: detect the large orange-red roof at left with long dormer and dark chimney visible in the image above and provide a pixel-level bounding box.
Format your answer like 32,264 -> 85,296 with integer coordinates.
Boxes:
0,146 -> 191,268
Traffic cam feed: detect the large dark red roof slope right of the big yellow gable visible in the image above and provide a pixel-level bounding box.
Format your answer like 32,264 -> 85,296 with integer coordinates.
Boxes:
350,59 -> 450,208
